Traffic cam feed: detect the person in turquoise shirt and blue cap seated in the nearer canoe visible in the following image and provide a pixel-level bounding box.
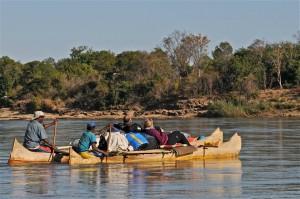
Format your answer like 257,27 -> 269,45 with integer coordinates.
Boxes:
78,122 -> 107,159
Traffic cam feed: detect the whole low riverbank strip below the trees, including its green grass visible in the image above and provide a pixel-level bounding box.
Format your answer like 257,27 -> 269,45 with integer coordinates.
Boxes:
0,88 -> 300,120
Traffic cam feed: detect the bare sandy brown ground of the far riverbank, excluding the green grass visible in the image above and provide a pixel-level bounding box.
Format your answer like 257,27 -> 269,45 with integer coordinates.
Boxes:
0,88 -> 300,120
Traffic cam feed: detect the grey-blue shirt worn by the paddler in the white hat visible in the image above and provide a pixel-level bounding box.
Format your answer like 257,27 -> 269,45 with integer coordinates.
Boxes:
23,120 -> 48,149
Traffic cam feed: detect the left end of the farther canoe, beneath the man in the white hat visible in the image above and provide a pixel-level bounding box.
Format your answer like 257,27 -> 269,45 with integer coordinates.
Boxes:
8,138 -> 69,165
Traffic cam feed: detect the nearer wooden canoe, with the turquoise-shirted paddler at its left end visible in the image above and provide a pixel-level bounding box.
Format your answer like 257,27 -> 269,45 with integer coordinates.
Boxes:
69,129 -> 242,165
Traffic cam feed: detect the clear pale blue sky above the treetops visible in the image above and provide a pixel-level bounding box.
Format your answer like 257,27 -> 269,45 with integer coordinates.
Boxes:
0,0 -> 300,62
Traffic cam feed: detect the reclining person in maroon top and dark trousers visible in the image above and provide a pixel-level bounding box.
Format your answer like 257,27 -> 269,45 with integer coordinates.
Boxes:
144,119 -> 191,146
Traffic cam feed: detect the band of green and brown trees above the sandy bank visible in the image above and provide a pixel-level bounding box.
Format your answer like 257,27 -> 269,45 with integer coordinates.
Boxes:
0,31 -> 300,110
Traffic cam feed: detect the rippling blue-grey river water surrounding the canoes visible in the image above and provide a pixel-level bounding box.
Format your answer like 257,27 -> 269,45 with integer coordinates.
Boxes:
0,118 -> 300,199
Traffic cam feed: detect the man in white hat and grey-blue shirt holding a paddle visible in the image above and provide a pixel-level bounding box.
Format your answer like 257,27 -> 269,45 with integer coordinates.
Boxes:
23,111 -> 57,153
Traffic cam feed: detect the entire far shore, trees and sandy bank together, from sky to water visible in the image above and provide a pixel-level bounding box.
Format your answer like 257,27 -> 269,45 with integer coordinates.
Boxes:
0,31 -> 300,117
